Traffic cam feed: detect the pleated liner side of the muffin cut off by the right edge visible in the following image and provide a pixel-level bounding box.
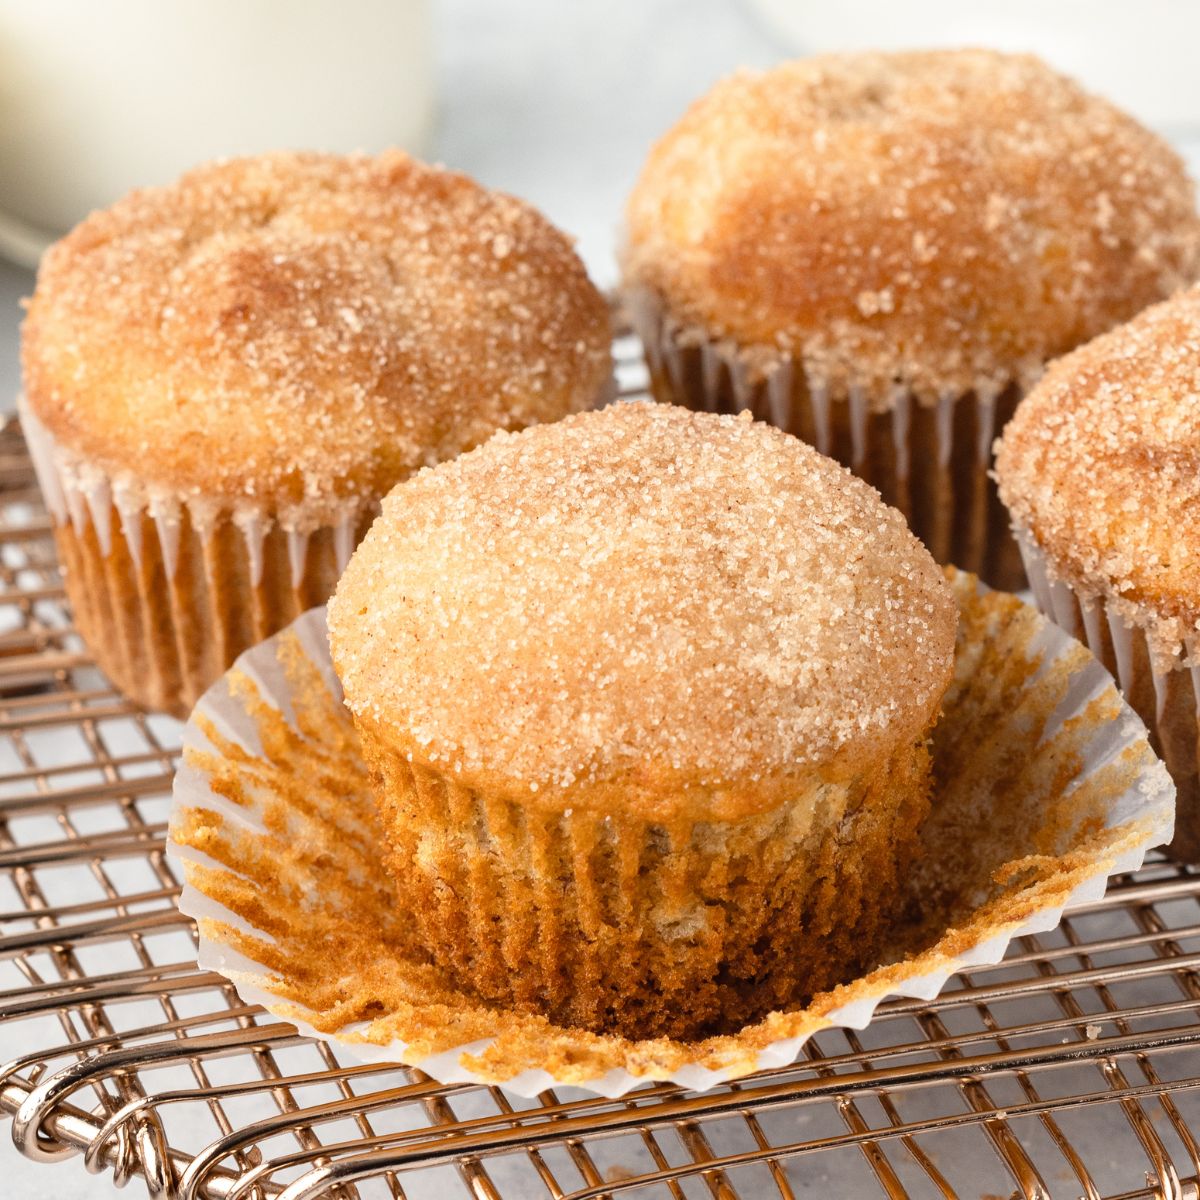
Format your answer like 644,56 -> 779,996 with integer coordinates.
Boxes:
1016,530 -> 1200,863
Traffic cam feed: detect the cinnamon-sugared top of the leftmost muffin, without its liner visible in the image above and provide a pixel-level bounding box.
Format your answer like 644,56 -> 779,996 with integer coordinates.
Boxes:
23,151 -> 611,524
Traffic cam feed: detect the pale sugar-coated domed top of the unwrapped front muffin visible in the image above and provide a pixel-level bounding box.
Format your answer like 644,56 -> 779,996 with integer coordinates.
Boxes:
329,403 -> 956,815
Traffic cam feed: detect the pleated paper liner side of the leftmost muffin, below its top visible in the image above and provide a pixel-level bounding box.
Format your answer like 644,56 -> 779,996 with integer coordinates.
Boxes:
18,401 -> 369,718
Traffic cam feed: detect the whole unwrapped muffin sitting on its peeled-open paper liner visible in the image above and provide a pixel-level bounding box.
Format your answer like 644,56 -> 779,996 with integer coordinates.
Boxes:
329,404 -> 956,1037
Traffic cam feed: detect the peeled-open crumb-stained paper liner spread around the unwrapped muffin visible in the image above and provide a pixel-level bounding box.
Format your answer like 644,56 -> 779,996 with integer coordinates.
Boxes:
169,572 -> 1174,1096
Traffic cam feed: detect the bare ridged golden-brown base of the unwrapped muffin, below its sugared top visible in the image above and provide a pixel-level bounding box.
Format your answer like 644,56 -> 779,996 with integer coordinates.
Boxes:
356,721 -> 930,1038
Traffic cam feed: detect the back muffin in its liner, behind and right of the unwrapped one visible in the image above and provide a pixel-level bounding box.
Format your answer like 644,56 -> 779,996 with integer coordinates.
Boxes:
624,50 -> 1200,588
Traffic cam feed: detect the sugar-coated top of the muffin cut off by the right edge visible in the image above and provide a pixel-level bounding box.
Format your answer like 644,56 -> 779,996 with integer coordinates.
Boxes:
996,288 -> 1200,672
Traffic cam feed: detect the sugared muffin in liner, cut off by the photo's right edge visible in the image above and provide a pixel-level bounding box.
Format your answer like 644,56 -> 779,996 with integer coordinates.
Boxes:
996,289 -> 1200,862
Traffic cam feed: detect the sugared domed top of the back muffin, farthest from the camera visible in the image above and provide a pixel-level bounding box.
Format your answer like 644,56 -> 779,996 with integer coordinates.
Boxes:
625,50 -> 1200,407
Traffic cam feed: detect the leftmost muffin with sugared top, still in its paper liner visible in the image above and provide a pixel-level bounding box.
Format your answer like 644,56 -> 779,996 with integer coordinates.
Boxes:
23,151 -> 612,714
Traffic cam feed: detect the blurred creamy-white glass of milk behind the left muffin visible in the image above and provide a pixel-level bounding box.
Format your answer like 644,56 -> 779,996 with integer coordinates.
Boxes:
0,0 -> 433,263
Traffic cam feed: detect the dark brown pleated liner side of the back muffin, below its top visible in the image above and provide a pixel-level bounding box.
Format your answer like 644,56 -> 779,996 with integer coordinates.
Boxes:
630,293 -> 1025,592
